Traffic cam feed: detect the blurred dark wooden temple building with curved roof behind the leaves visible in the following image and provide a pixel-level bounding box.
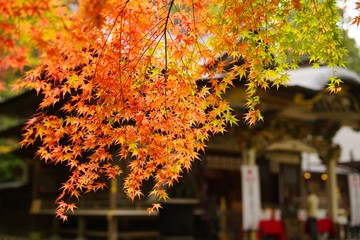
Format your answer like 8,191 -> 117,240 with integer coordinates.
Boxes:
0,66 -> 360,240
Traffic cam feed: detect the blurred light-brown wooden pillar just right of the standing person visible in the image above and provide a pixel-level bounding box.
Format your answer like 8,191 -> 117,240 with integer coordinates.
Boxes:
327,158 -> 338,223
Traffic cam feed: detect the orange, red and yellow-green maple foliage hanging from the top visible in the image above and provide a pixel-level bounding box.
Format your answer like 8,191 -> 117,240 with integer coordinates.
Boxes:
0,0 -> 354,220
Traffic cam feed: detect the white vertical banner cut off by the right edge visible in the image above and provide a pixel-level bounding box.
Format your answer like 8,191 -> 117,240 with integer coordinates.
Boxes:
348,173 -> 360,226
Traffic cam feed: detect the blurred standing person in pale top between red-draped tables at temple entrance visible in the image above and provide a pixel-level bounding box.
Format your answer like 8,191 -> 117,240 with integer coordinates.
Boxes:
306,190 -> 319,240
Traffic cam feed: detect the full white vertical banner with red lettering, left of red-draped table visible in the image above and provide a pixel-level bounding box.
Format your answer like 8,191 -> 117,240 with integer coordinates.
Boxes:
241,165 -> 261,231
